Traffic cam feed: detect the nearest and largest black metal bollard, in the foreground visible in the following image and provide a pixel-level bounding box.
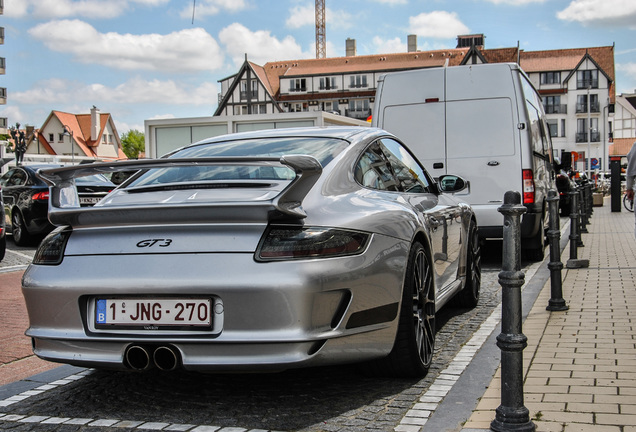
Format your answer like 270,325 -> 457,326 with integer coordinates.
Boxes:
490,191 -> 535,432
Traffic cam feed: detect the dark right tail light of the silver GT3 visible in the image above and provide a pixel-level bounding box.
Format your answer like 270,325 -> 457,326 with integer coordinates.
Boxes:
256,225 -> 371,261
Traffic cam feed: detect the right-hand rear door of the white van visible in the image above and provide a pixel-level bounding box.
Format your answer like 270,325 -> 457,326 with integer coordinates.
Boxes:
446,64 -> 522,231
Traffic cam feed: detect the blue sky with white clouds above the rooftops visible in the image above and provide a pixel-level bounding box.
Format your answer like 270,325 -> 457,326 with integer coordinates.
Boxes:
0,0 -> 636,134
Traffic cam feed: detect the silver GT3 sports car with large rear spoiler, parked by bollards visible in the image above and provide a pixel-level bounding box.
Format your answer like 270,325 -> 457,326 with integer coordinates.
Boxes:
22,127 -> 481,376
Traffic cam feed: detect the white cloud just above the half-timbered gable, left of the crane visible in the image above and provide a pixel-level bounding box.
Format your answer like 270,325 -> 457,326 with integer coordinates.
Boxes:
219,23 -> 311,66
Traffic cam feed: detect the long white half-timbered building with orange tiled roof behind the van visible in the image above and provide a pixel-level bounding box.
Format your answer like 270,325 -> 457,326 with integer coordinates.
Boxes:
214,34 -> 615,172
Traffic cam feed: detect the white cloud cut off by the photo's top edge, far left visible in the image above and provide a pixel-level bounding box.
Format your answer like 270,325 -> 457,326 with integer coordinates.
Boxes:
4,0 -> 170,19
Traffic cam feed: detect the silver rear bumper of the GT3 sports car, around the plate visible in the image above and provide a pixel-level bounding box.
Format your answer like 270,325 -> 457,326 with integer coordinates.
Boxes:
23,235 -> 409,371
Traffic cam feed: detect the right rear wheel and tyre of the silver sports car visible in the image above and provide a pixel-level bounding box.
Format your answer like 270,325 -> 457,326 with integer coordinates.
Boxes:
365,242 -> 435,378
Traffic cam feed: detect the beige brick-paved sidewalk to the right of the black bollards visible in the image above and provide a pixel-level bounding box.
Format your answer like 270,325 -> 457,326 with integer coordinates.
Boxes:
462,198 -> 636,432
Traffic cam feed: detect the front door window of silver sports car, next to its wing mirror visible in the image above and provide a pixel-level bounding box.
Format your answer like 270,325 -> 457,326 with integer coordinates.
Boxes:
381,138 -> 430,193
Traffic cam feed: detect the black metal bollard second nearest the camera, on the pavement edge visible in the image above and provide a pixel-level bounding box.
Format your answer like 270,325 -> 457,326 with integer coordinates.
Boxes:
546,189 -> 569,311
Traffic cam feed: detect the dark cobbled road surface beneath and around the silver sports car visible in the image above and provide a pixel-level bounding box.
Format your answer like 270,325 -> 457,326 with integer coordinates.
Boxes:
0,238 -> 516,432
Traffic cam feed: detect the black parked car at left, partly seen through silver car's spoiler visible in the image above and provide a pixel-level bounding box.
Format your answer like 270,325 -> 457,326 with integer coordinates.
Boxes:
0,165 -> 115,245
